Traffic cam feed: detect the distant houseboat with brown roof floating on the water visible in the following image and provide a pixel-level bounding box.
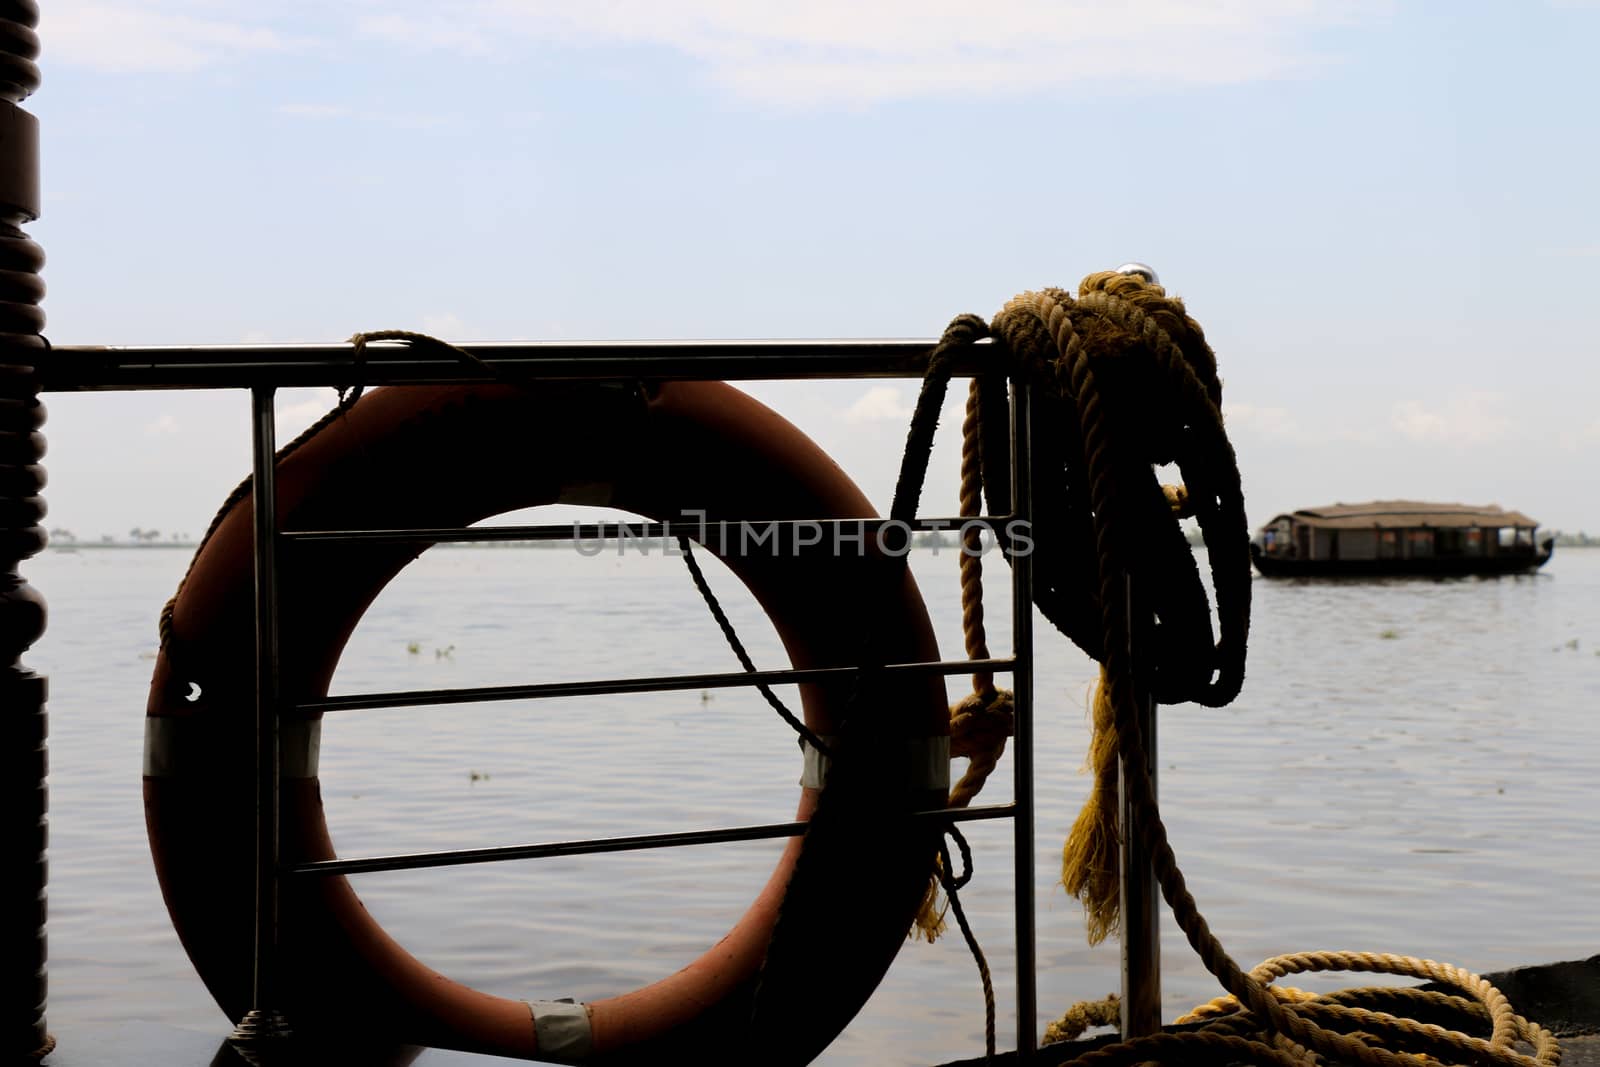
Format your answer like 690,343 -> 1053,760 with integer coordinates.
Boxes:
1250,501 -> 1555,577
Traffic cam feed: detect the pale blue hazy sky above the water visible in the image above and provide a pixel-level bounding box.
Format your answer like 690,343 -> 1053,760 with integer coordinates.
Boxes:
26,0 -> 1600,539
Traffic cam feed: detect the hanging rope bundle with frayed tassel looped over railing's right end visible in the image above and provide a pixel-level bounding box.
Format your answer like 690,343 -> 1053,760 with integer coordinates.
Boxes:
896,272 -> 1250,941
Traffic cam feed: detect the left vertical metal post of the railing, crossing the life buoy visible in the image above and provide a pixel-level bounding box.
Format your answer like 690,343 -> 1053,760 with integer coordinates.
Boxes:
230,386 -> 290,1053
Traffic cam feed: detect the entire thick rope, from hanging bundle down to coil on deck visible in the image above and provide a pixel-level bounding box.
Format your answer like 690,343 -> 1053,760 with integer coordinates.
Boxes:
894,272 -> 1560,1067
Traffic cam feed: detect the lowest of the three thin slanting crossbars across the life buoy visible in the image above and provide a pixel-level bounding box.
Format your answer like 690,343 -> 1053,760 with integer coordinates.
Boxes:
285,805 -> 1016,875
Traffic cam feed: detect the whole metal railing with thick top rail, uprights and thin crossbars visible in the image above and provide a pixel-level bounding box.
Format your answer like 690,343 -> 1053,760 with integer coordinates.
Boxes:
38,341 -> 1037,1064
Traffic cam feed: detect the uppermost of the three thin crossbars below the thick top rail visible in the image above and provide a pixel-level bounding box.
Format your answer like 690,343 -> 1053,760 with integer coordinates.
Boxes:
280,515 -> 1013,550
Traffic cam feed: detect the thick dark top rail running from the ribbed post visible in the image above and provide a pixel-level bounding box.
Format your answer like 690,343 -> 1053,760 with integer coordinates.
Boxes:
37,338 -> 994,392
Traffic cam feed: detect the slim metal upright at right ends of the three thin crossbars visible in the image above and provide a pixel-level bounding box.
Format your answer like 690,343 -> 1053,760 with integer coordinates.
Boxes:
1011,376 -> 1038,1064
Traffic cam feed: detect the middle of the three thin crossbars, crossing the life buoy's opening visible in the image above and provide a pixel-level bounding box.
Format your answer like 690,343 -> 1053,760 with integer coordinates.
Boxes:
302,657 -> 1016,712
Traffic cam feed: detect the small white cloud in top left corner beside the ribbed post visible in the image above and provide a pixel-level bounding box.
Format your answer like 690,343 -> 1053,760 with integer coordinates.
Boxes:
40,0 -> 299,74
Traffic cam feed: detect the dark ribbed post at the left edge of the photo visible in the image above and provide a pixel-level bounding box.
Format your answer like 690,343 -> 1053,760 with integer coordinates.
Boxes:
0,0 -> 54,1064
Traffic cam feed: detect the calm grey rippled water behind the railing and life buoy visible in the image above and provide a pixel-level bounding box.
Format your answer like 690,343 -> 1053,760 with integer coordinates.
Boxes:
26,549 -> 1600,1064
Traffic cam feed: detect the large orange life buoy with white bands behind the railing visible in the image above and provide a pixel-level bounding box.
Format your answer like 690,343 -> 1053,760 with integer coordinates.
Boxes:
144,382 -> 947,1062
